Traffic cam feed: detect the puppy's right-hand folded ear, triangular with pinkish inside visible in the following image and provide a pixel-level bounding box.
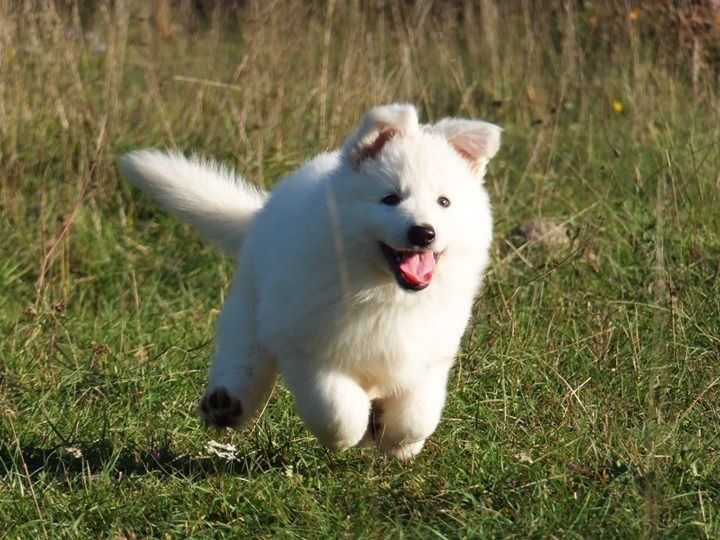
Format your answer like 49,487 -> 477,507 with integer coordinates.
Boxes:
432,118 -> 502,175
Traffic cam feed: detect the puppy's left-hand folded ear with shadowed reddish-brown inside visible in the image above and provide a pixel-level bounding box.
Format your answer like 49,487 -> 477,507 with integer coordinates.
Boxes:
344,104 -> 418,170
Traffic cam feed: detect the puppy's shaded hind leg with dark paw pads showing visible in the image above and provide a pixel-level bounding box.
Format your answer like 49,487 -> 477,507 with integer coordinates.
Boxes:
199,270 -> 277,428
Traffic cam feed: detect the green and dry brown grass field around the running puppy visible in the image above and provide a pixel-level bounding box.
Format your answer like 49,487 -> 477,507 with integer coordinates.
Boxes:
0,0 -> 720,538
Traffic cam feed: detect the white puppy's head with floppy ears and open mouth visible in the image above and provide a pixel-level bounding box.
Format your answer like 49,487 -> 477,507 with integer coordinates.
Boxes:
341,105 -> 501,291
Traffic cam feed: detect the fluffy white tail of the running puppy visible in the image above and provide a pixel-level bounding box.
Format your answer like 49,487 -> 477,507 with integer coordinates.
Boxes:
119,150 -> 267,253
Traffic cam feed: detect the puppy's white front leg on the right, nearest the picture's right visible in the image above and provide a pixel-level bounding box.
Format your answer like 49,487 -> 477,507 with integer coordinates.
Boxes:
374,362 -> 451,460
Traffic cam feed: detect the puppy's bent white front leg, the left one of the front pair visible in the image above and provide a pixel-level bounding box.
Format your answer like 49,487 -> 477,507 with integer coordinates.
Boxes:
283,368 -> 370,450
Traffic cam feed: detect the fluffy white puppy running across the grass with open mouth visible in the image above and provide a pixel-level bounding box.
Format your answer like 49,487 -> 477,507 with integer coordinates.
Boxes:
120,104 -> 502,460
